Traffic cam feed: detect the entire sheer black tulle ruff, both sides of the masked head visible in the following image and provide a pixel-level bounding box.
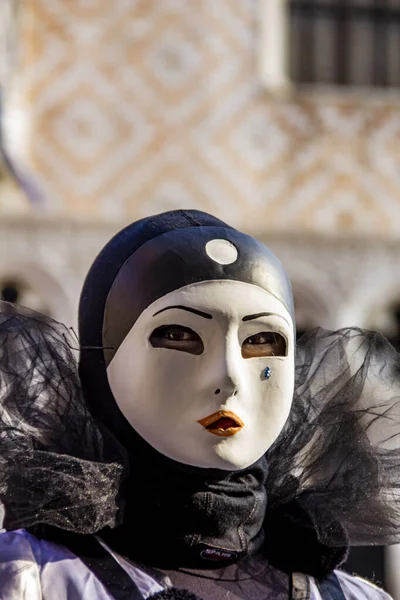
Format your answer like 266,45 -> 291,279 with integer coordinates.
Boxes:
0,303 -> 400,547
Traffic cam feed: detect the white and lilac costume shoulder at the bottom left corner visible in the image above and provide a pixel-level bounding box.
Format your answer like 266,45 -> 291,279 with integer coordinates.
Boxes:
0,529 -> 112,600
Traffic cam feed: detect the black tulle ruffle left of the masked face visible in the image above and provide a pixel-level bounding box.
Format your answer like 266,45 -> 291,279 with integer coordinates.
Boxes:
0,302 -> 123,533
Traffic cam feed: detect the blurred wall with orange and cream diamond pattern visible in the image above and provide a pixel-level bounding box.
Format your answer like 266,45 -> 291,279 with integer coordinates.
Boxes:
8,0 -> 400,236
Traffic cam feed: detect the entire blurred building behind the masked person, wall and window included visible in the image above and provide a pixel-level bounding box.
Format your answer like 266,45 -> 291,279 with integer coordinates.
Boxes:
0,0 -> 400,598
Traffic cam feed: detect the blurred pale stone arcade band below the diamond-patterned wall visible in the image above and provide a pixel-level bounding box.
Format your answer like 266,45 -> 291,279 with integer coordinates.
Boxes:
0,218 -> 400,335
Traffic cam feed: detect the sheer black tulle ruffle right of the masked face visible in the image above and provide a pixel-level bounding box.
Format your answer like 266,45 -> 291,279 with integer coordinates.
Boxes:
268,328 -> 400,547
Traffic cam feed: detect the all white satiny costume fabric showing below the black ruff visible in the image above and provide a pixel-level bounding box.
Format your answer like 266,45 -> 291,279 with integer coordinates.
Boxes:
0,529 -> 390,600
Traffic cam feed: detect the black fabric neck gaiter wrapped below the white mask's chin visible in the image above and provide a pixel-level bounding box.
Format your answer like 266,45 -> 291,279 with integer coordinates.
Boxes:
101,433 -> 267,569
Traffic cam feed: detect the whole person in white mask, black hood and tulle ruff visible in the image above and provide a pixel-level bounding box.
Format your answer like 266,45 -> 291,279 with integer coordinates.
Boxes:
0,210 -> 400,600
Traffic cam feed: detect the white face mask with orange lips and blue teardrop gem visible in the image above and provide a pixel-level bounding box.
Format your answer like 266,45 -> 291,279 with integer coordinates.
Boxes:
107,280 -> 294,470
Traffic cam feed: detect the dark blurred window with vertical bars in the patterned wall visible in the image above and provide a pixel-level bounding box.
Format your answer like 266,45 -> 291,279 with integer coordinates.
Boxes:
289,0 -> 400,87
